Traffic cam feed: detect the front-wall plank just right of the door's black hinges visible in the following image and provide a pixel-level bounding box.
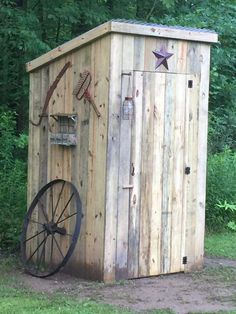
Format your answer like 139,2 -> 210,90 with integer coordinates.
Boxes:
184,43 -> 200,271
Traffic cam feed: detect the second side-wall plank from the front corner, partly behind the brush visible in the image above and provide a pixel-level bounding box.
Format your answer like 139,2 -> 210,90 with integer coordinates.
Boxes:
73,45 -> 91,277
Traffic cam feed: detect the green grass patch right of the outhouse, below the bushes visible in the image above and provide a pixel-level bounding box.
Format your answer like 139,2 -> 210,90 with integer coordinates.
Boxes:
205,232 -> 236,259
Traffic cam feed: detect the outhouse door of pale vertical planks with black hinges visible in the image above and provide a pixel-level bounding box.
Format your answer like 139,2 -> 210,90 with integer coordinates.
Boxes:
116,71 -> 199,278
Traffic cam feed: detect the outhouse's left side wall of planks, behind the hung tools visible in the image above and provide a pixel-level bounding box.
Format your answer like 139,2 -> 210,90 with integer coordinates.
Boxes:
28,36 -> 110,280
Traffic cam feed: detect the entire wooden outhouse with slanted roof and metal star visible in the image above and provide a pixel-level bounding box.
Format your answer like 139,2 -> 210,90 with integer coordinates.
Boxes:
27,20 -> 217,282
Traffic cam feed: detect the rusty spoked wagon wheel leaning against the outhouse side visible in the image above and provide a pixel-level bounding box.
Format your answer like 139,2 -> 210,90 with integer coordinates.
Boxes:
21,179 -> 82,278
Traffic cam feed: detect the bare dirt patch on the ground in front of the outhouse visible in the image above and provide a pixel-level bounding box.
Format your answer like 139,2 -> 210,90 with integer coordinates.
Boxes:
13,258 -> 236,314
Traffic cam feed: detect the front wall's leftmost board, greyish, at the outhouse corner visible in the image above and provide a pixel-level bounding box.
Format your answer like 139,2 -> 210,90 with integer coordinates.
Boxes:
104,34 -> 122,281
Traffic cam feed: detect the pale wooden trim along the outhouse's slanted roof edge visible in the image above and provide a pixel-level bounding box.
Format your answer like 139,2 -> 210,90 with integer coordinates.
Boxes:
26,19 -> 218,72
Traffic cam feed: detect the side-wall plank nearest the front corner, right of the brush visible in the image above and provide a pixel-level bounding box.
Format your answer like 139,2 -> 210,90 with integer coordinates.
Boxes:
86,37 -> 110,280
